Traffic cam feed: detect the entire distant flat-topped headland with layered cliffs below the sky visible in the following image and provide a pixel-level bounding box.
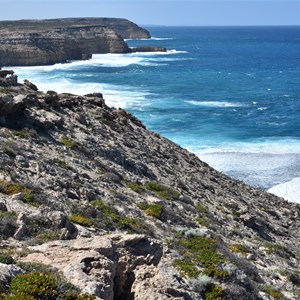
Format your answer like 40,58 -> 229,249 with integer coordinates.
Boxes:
0,18 -> 150,66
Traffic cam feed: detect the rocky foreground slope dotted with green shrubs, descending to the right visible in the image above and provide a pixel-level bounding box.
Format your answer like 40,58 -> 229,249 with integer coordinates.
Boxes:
0,73 -> 300,300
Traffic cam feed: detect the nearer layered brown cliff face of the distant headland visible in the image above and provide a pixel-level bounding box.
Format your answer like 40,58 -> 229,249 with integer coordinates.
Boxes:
0,26 -> 130,66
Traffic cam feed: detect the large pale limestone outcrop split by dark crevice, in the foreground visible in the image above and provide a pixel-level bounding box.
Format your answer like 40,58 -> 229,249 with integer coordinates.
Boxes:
22,234 -> 170,300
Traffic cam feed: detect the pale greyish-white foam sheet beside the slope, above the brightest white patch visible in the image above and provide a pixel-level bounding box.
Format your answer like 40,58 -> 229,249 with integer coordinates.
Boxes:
188,141 -> 300,191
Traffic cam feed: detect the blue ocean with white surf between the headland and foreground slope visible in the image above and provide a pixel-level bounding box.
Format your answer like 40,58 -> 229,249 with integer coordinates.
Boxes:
10,26 -> 300,202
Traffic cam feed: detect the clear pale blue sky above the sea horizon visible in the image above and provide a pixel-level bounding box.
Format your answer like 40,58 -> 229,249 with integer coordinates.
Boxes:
0,0 -> 300,26
